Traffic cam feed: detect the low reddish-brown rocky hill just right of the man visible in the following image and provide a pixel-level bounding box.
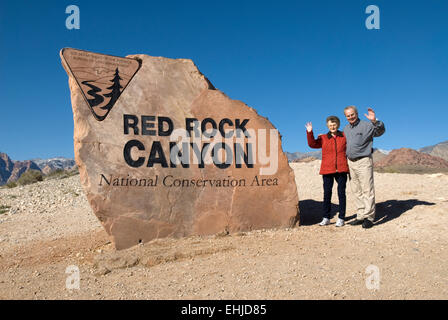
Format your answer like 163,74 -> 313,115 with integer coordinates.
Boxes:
375,148 -> 448,169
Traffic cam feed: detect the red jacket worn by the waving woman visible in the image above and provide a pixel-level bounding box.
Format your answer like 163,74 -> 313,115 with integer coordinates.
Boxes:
306,131 -> 349,174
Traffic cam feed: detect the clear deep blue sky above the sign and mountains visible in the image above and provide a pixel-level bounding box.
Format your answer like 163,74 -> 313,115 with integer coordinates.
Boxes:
0,0 -> 448,160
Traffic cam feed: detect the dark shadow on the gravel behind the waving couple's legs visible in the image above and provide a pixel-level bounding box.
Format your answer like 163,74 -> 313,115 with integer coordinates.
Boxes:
299,199 -> 435,226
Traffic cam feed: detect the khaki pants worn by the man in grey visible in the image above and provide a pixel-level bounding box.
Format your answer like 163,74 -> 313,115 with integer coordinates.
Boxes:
348,156 -> 375,222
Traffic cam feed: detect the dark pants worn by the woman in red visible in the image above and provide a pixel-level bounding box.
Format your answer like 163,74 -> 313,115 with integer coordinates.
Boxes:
322,172 -> 347,219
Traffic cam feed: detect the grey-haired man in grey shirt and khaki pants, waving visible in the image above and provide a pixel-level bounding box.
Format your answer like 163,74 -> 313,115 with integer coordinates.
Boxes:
344,106 -> 386,229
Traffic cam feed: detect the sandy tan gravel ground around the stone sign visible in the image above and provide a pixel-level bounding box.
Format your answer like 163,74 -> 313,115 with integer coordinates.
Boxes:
0,160 -> 448,299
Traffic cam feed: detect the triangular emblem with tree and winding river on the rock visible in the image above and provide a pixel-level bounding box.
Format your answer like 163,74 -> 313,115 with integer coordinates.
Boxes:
61,48 -> 140,121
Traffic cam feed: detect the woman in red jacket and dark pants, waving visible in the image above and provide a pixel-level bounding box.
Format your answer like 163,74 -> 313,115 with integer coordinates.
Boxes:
305,116 -> 349,227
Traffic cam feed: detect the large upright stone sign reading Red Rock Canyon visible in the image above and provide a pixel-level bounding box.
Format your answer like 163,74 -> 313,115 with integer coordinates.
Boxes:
61,48 -> 298,249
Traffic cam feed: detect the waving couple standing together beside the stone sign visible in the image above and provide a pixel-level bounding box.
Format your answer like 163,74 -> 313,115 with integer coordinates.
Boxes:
305,106 -> 386,228
